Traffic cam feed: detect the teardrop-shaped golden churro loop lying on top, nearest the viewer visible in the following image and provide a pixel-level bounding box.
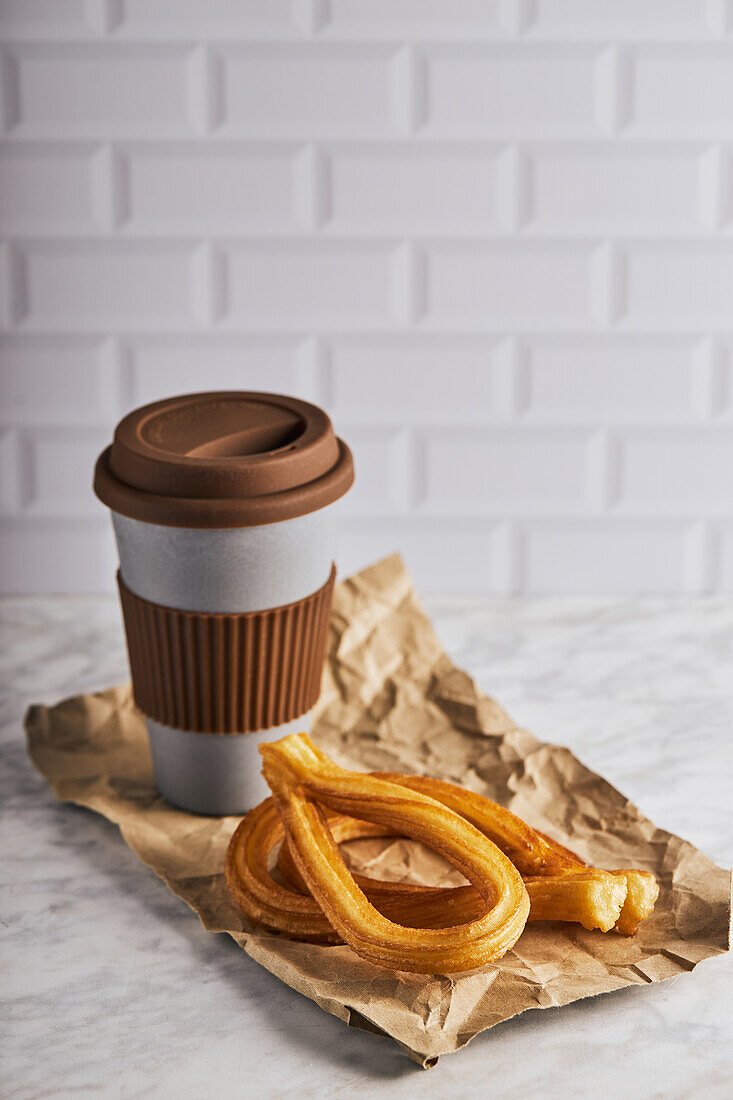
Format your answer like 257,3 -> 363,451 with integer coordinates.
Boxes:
260,734 -> 529,974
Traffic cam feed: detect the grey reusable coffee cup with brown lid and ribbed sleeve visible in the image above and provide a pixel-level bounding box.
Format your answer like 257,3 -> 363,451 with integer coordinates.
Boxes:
94,391 -> 353,815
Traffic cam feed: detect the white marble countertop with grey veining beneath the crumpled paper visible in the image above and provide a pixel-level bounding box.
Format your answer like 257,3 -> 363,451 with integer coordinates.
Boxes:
0,597 -> 733,1100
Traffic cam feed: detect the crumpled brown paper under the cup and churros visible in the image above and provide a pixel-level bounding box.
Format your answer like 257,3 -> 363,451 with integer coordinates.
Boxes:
25,557 -> 731,1066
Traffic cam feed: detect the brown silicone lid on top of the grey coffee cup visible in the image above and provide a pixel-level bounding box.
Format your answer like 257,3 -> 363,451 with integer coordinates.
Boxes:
94,391 -> 353,527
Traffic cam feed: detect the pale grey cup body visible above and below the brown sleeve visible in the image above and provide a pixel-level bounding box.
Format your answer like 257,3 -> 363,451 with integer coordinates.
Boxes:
112,502 -> 338,815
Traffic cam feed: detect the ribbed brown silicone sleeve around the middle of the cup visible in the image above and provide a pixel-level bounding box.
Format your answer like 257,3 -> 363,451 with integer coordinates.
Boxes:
117,567 -> 336,734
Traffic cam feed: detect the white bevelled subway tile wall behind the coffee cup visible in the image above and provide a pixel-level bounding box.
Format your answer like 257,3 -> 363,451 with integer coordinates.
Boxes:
0,0 -> 733,593
